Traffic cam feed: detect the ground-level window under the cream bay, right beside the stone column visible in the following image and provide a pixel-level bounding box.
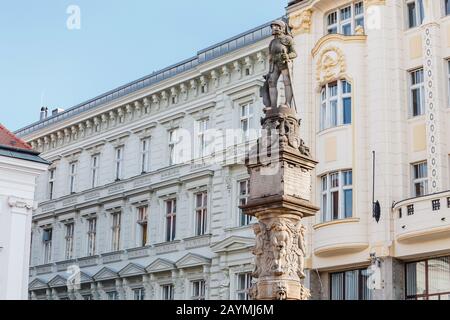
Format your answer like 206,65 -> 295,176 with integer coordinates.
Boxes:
330,269 -> 372,300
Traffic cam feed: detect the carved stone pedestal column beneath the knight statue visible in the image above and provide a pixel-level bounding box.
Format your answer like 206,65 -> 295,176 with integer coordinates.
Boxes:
242,105 -> 319,300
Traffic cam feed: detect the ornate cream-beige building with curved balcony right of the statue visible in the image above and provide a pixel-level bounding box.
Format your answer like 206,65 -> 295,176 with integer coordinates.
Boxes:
288,0 -> 450,299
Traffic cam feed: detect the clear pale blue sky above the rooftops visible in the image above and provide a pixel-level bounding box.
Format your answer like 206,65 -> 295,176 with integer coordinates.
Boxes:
0,0 -> 287,130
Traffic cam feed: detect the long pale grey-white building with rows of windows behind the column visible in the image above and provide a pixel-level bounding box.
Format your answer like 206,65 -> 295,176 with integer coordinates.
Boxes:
18,25 -> 271,299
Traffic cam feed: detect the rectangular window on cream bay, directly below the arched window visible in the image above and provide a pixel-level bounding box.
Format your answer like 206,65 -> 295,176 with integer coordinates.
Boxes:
321,170 -> 353,222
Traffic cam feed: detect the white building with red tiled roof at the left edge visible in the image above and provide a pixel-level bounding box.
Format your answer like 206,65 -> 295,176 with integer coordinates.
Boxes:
0,125 -> 48,300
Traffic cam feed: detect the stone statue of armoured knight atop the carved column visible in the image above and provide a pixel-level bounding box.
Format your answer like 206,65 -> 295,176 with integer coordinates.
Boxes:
261,20 -> 297,111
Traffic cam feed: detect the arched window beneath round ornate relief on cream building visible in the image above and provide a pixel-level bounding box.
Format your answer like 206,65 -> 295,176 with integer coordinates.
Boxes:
320,80 -> 352,130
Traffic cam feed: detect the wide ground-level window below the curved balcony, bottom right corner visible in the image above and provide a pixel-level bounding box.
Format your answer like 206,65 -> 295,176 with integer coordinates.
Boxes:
406,256 -> 450,300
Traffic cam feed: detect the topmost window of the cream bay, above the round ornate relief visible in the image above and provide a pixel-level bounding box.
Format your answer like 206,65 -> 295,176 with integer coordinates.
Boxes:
325,1 -> 364,36
